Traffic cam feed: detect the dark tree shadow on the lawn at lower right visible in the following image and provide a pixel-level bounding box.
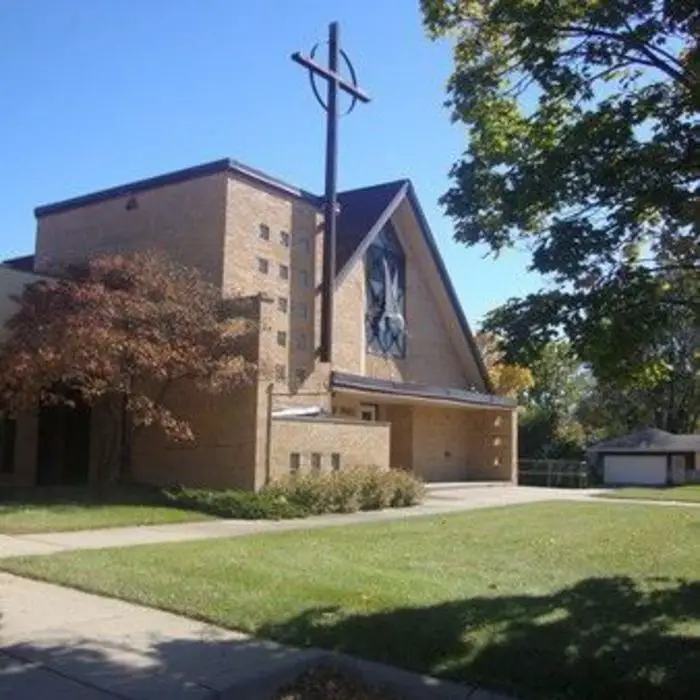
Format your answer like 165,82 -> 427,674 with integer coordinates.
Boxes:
259,577 -> 700,699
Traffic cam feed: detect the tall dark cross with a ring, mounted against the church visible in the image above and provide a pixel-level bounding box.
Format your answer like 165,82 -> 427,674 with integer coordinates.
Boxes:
292,22 -> 370,362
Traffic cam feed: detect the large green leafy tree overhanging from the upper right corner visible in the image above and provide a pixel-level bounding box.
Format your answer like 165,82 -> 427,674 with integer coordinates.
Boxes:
422,0 -> 700,394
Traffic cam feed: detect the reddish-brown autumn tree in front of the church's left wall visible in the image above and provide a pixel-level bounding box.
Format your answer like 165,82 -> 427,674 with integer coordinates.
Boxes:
0,253 -> 254,476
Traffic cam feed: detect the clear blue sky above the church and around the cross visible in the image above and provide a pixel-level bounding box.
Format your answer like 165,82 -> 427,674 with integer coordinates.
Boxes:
0,0 -> 540,325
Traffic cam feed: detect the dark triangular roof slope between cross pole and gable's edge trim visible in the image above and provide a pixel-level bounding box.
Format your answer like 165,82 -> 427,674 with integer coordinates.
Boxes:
335,180 -> 408,272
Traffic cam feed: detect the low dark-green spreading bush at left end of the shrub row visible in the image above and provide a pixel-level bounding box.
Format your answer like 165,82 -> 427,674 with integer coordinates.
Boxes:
164,487 -> 311,520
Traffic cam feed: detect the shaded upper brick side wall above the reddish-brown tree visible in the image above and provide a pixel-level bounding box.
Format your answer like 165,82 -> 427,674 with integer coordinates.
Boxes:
36,173 -> 226,284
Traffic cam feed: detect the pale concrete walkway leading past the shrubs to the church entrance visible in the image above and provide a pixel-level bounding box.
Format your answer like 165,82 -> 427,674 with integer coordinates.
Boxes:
0,484 -> 598,557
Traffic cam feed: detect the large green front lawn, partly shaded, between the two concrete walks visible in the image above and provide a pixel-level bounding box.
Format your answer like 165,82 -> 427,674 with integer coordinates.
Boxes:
5,503 -> 700,698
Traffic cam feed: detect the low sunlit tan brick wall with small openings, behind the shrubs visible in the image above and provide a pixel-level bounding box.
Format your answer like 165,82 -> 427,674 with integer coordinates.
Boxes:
270,419 -> 389,480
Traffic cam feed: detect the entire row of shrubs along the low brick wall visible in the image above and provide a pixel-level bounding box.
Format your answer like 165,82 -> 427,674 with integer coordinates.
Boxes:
165,467 -> 424,520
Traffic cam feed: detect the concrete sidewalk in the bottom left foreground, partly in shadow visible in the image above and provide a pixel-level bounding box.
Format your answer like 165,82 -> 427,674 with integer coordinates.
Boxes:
0,574 -> 507,700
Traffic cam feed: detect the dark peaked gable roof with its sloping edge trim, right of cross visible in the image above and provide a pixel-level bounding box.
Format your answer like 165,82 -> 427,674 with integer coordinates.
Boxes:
336,179 -> 493,391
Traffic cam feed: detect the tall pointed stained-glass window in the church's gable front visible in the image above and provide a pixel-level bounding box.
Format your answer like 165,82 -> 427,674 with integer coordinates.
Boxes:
365,224 -> 406,357
